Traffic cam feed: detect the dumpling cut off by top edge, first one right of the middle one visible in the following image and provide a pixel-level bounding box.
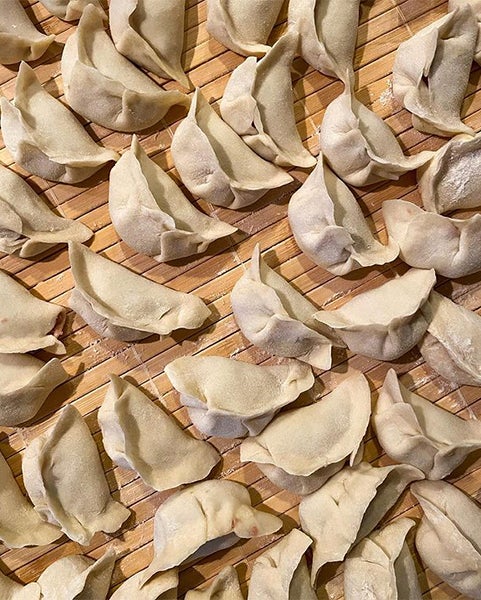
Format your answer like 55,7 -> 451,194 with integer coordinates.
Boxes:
288,0 -> 361,85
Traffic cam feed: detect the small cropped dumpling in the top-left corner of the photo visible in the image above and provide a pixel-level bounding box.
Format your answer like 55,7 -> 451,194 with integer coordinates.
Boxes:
0,0 -> 55,65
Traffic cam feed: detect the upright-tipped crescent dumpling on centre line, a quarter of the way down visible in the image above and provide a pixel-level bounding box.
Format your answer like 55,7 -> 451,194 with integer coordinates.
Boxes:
171,89 -> 292,209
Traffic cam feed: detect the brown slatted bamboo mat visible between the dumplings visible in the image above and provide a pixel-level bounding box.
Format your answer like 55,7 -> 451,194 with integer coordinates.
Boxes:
0,0 -> 481,600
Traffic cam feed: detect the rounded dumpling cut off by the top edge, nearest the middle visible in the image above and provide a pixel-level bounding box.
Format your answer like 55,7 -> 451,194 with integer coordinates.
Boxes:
207,0 -> 284,56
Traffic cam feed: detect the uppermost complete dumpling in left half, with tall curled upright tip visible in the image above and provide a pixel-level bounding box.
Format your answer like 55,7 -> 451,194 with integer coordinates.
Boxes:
62,5 -> 189,132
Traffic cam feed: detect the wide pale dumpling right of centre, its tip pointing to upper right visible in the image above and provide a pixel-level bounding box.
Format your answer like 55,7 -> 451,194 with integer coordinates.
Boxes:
315,269 -> 436,360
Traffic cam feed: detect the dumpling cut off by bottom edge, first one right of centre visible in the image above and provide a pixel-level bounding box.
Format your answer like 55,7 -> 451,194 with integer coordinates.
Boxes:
247,529 -> 317,600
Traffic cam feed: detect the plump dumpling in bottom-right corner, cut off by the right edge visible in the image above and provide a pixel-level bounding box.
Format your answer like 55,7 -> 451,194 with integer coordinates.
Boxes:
411,481 -> 481,600
